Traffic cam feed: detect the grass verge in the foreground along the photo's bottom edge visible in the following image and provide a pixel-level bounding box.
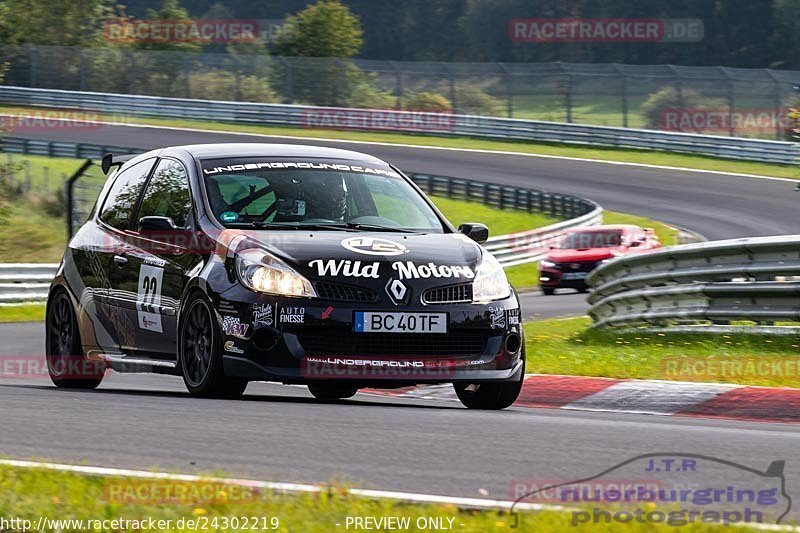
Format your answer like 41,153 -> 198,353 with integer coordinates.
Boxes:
0,466 -> 776,533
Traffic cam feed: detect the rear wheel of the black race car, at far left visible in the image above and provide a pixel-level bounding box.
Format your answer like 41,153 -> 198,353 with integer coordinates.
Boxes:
45,288 -> 106,389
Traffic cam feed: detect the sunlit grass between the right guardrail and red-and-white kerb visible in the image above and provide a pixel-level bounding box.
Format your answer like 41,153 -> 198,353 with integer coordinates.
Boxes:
525,317 -> 800,387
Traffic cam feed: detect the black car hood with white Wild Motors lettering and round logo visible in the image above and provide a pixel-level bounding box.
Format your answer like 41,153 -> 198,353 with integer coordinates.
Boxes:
230,231 -> 482,285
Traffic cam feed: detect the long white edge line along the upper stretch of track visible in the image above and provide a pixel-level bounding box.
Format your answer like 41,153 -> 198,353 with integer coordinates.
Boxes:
0,113 -> 799,183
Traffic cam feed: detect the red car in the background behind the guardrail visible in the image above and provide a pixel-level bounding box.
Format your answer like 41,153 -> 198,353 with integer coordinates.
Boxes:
539,224 -> 661,294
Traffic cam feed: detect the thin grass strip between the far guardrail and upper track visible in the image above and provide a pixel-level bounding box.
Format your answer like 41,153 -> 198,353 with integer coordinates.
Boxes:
0,106 -> 800,179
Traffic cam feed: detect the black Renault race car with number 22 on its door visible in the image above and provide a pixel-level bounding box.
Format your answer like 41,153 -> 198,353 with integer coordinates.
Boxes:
46,144 -> 525,409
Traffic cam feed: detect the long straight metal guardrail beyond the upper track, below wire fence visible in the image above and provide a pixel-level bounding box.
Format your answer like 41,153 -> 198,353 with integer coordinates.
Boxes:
0,86 -> 800,164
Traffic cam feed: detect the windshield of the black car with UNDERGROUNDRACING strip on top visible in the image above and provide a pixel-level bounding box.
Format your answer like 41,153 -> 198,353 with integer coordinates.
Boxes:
202,158 -> 444,233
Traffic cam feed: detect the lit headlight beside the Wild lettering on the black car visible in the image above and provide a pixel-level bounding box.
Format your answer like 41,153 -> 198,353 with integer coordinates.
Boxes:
236,248 -> 317,298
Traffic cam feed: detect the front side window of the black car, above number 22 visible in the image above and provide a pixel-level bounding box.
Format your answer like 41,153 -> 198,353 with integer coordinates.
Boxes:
138,159 -> 192,228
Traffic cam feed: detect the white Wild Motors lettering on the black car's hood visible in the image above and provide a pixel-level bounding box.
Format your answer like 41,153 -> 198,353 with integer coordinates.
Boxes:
308,259 -> 468,280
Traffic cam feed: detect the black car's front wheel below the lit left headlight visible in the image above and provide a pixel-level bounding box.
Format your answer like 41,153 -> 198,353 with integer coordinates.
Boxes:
178,295 -> 247,398
